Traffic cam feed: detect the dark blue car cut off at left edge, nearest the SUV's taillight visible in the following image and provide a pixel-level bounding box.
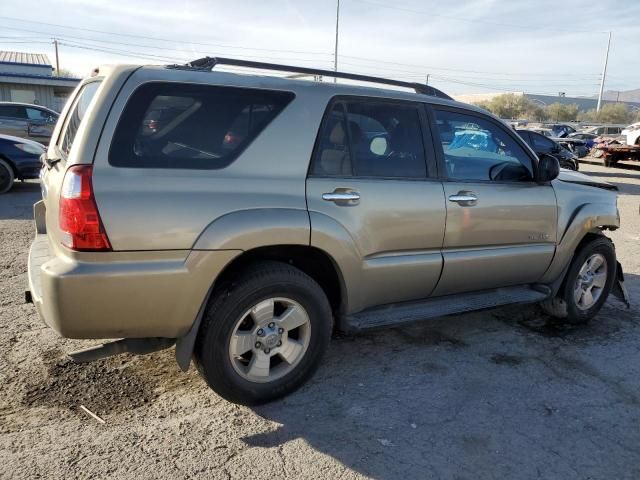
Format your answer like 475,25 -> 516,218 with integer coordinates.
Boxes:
0,135 -> 45,193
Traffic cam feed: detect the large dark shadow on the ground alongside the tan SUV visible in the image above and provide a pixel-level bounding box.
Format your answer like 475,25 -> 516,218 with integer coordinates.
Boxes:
242,275 -> 640,479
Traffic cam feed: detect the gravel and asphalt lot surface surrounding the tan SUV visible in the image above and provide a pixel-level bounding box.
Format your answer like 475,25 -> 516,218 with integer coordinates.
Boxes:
0,165 -> 640,480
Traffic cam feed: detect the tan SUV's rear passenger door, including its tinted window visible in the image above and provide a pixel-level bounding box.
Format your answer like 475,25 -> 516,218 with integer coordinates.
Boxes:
307,97 -> 445,311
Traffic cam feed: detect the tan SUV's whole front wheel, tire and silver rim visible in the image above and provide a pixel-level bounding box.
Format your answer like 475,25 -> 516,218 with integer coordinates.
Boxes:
542,236 -> 617,325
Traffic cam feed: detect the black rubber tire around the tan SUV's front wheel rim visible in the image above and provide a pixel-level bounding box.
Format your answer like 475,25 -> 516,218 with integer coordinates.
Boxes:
542,236 -> 617,325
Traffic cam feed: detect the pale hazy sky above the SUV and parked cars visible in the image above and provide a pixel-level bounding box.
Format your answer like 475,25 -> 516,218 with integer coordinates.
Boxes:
0,0 -> 640,96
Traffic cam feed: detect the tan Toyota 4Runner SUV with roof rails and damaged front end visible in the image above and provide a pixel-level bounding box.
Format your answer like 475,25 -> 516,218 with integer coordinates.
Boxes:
27,57 -> 624,404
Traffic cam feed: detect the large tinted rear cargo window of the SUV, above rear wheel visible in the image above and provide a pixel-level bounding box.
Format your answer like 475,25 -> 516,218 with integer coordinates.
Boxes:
109,82 -> 294,169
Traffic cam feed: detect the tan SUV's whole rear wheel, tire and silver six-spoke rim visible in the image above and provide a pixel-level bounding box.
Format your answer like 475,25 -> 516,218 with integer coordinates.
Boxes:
195,262 -> 332,405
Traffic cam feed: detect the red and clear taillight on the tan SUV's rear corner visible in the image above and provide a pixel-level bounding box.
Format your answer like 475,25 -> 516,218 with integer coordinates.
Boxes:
59,165 -> 111,251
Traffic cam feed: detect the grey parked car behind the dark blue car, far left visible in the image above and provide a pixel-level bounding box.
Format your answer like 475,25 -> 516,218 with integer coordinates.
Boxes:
0,102 -> 60,144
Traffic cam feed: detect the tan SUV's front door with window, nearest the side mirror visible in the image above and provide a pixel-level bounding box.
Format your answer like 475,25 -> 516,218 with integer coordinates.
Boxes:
432,107 -> 557,295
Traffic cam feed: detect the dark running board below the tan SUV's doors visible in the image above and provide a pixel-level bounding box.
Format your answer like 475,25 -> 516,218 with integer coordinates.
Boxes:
342,285 -> 551,331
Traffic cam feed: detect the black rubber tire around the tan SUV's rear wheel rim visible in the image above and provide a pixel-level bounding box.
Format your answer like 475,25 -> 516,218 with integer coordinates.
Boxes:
194,262 -> 333,405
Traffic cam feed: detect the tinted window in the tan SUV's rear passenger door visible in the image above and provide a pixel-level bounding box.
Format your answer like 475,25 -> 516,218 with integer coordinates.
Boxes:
311,100 -> 427,178
